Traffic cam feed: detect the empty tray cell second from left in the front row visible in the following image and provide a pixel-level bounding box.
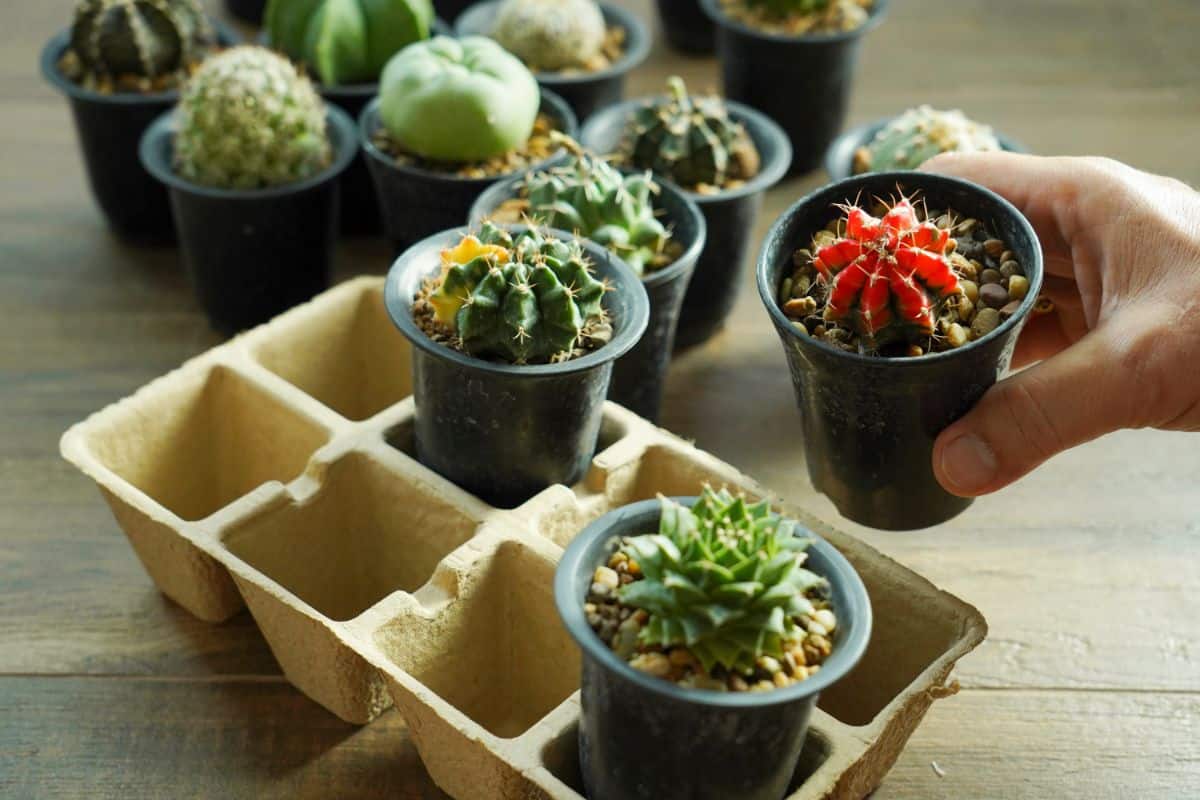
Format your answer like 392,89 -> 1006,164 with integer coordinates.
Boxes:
224,452 -> 476,620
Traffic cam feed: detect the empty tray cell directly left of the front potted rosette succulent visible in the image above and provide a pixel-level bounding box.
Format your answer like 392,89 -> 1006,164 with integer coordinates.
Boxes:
377,541 -> 580,739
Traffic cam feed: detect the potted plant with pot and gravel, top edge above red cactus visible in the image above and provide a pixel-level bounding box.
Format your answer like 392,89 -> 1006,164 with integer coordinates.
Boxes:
701,0 -> 888,173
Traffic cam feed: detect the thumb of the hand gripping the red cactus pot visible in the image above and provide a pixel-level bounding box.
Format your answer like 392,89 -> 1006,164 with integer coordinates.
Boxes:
934,324 -> 1136,497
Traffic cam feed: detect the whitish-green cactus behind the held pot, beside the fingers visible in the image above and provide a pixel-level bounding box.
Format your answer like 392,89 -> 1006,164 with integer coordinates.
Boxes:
854,106 -> 1001,173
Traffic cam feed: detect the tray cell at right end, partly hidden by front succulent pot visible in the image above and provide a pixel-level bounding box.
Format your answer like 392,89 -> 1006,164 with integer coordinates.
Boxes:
817,559 -> 964,726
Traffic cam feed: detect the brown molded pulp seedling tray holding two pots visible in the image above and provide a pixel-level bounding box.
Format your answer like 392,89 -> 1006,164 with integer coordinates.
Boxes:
61,277 -> 986,800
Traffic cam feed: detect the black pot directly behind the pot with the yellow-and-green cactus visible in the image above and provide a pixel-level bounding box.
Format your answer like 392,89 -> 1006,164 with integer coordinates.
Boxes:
470,172 -> 706,422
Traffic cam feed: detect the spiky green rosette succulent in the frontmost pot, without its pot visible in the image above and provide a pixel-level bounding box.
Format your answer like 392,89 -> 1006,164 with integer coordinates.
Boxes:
617,488 -> 826,673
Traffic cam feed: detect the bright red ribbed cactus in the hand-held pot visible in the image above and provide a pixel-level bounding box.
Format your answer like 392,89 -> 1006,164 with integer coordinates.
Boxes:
812,197 -> 959,341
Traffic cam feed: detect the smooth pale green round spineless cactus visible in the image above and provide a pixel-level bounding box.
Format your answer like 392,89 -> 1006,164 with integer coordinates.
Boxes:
379,36 -> 541,162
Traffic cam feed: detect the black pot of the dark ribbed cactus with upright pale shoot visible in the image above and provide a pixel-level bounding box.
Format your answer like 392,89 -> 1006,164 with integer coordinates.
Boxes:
580,98 -> 792,350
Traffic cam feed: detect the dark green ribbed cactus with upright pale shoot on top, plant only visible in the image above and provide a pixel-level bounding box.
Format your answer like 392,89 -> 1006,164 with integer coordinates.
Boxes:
623,77 -> 761,187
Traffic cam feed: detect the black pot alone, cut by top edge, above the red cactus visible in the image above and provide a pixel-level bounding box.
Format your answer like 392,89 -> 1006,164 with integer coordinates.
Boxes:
700,0 -> 888,174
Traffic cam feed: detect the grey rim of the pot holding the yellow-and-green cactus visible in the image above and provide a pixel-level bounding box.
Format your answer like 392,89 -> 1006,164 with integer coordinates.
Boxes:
384,224 -> 650,378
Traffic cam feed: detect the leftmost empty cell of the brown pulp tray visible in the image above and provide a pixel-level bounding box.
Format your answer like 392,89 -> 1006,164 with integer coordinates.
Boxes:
88,366 -> 329,519
